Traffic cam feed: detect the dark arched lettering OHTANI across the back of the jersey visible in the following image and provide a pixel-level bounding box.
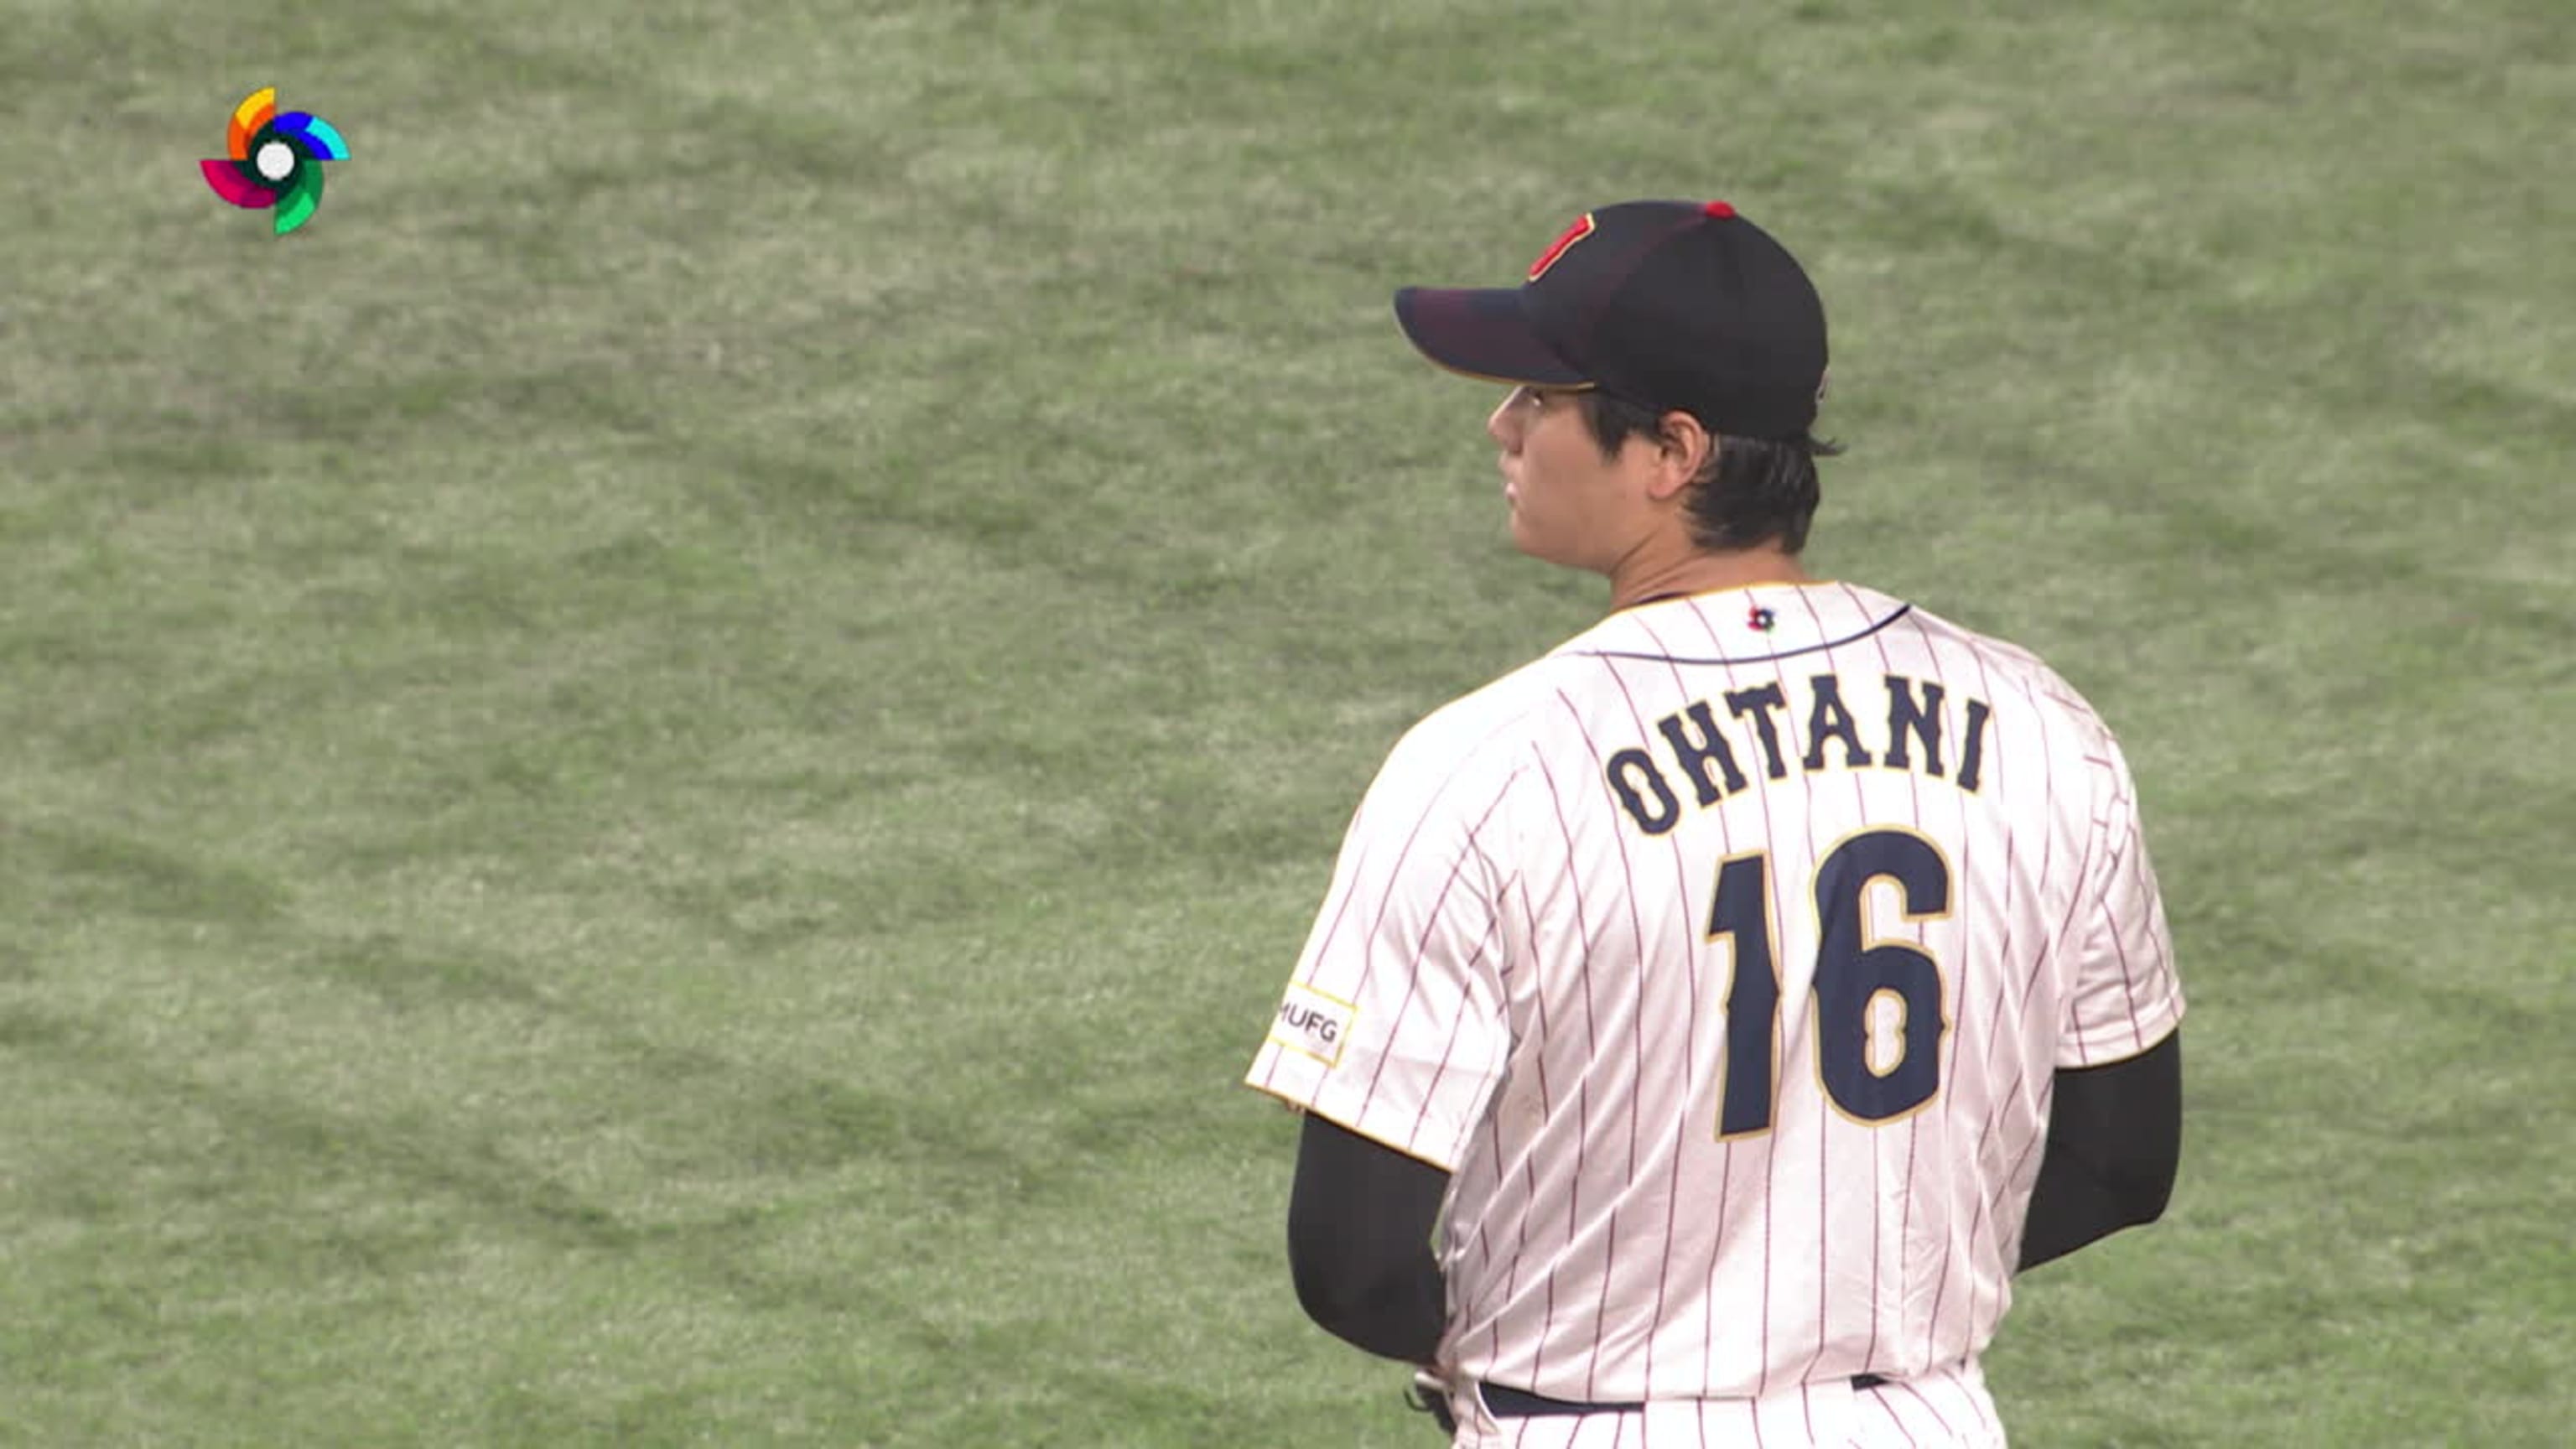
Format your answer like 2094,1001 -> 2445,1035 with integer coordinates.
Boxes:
1605,673 -> 1994,835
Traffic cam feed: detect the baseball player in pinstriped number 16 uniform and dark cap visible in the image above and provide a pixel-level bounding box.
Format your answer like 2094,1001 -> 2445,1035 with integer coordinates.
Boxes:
1247,201 -> 2182,1449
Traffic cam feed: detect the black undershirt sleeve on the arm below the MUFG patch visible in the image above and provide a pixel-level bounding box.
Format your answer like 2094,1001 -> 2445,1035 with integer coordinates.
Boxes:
1288,1114 -> 1447,1364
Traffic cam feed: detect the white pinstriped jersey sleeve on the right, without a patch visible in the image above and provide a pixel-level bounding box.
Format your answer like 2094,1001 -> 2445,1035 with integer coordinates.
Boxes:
2055,732 -> 2182,1067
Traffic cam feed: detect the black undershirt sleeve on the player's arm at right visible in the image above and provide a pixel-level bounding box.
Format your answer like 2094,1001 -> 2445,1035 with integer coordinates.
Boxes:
2019,1031 -> 2182,1269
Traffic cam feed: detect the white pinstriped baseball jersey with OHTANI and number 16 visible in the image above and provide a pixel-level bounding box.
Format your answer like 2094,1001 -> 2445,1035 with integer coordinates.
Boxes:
1247,583 -> 2182,1403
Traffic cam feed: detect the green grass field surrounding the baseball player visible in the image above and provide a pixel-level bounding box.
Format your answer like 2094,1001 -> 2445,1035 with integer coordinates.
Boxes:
0,0 -> 2576,1449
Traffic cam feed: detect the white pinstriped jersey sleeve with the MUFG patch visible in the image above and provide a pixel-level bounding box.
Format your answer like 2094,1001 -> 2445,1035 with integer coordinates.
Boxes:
1244,727 -> 1512,1171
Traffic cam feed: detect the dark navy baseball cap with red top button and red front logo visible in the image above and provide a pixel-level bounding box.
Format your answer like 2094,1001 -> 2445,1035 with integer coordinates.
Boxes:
1396,201 -> 1826,439
